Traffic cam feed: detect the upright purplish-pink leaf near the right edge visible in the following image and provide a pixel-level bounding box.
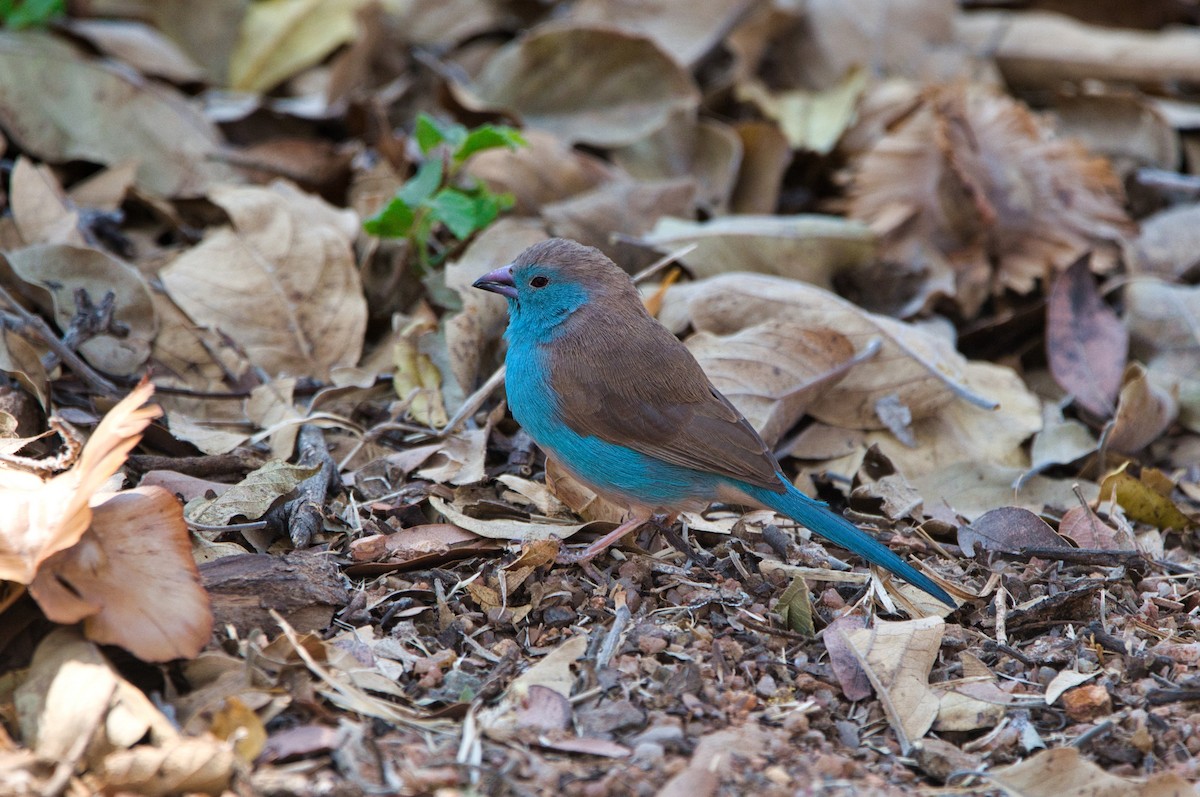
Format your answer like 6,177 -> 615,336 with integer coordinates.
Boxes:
1046,254 -> 1129,418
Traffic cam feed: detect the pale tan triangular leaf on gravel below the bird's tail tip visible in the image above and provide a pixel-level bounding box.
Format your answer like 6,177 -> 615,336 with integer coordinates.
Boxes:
844,617 -> 946,750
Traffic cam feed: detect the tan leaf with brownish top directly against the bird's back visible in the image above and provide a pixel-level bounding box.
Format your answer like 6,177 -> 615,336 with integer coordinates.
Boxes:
688,318 -> 854,445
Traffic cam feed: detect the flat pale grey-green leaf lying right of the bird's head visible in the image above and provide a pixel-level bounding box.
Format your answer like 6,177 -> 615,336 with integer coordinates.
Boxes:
642,215 -> 876,288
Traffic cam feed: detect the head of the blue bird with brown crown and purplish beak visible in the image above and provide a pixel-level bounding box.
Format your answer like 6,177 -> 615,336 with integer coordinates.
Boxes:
474,238 -> 641,331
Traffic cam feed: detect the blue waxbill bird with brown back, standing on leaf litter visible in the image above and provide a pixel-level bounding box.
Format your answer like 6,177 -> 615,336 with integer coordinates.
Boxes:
474,239 -> 955,607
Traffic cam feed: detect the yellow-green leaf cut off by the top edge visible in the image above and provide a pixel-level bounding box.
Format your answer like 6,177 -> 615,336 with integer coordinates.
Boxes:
229,0 -> 366,92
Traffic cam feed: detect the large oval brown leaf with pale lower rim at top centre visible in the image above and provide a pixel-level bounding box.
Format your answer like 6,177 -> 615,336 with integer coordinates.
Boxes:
452,24 -> 700,146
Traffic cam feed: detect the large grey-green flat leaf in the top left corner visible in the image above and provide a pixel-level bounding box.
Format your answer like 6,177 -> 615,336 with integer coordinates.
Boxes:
0,30 -> 233,197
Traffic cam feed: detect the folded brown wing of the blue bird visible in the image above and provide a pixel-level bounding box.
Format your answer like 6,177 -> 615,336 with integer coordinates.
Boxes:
550,306 -> 784,492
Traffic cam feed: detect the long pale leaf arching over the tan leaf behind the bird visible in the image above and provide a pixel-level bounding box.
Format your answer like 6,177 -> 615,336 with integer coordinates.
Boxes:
660,274 -> 991,429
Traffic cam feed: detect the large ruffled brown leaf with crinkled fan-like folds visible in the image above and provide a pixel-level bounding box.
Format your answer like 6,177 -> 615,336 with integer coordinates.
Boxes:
850,83 -> 1133,316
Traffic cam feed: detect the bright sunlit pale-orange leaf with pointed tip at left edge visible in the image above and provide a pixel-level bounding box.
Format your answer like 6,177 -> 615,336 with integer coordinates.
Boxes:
0,382 -> 162,585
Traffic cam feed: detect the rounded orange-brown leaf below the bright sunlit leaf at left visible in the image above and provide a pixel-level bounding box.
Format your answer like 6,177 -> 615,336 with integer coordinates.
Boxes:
29,487 -> 212,661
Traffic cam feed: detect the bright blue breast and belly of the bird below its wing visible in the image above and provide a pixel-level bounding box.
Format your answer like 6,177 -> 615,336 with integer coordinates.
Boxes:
505,335 -> 719,509
